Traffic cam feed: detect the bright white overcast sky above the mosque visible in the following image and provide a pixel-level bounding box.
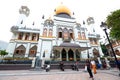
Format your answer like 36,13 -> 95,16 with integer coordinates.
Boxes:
0,0 -> 120,42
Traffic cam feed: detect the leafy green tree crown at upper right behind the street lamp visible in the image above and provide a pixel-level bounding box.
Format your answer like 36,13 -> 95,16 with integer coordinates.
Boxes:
106,9 -> 120,40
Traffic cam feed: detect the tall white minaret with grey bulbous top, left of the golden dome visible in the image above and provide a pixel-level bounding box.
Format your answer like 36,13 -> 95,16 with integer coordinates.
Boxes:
17,6 -> 30,27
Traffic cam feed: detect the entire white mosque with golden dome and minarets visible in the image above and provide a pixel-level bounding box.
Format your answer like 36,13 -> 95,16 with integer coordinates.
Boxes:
6,4 -> 103,61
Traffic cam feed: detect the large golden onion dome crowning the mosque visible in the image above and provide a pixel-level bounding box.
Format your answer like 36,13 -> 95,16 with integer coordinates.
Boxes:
55,4 -> 71,16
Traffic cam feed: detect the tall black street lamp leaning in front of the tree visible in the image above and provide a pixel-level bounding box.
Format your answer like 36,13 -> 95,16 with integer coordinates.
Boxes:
100,22 -> 120,76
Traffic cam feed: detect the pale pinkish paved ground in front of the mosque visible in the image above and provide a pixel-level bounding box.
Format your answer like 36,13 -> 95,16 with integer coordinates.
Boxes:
0,69 -> 120,80
